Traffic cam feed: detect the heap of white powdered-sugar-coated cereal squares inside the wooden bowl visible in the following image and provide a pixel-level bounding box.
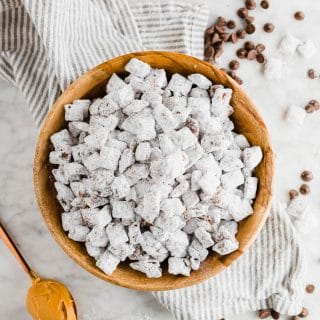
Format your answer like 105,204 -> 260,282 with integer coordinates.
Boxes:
49,59 -> 262,277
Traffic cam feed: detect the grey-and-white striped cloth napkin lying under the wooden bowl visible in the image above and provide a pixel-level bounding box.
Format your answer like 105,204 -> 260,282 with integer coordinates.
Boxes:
0,0 -> 304,320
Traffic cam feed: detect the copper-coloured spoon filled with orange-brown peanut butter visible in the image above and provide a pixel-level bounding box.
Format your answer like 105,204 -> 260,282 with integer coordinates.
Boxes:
0,223 -> 77,320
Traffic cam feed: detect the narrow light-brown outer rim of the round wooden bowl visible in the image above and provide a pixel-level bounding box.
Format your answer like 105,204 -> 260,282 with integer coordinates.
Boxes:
33,51 -> 274,291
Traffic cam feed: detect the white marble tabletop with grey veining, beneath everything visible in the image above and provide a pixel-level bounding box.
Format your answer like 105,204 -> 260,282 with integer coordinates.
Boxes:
0,0 -> 320,320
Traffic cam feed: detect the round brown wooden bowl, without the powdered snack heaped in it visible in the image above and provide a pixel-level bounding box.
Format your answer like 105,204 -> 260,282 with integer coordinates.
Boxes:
34,51 -> 274,290
